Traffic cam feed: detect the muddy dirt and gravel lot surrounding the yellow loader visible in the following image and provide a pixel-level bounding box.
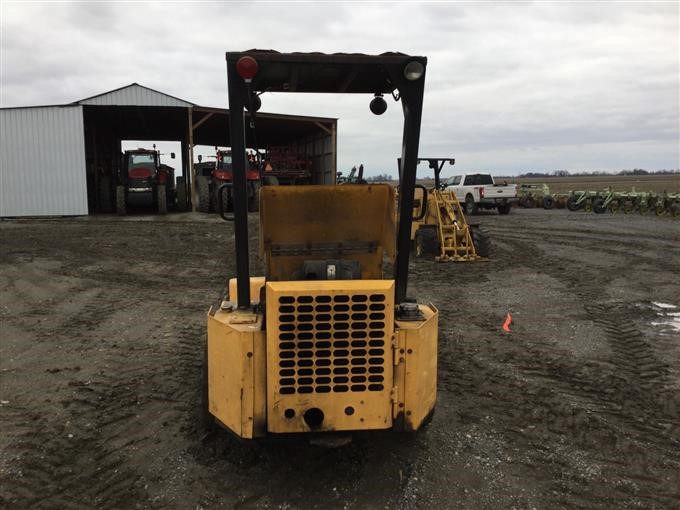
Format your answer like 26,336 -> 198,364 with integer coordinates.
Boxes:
0,209 -> 680,509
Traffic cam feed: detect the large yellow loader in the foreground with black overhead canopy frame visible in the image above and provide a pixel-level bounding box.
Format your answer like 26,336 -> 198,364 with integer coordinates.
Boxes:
206,50 -> 438,438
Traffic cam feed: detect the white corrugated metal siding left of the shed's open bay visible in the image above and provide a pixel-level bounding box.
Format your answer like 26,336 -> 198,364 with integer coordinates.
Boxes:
0,106 -> 87,217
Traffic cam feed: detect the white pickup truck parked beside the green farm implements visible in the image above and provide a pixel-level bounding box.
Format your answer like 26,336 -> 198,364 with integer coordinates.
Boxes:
442,174 -> 517,214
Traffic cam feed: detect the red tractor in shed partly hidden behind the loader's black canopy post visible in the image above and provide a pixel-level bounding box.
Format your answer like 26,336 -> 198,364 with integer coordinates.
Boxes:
194,150 -> 261,212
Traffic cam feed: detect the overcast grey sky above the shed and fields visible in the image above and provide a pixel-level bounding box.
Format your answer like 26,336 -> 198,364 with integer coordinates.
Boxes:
0,0 -> 680,175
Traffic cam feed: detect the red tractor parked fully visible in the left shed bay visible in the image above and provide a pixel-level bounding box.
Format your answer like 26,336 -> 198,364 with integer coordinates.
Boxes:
116,146 -> 175,215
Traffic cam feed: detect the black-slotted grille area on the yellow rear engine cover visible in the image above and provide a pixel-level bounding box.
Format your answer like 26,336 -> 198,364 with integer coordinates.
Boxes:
276,293 -> 390,395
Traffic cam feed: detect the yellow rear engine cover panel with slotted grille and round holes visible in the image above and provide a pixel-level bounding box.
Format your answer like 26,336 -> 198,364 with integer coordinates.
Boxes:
266,280 -> 394,433
